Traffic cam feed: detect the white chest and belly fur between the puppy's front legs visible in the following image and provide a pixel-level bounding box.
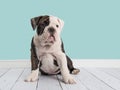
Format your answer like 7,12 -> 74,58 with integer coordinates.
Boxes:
36,46 -> 60,74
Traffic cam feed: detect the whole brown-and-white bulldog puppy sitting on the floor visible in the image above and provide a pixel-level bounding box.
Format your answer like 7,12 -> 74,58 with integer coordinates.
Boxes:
25,15 -> 80,84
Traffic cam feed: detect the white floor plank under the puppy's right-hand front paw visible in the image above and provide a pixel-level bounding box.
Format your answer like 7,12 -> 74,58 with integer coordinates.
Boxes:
57,75 -> 88,90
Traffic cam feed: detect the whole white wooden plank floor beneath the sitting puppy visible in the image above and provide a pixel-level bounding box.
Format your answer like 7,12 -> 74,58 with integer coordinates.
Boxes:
0,68 -> 120,90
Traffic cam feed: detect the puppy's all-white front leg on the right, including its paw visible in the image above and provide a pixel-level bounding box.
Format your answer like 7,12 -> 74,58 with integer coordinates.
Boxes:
57,53 -> 75,84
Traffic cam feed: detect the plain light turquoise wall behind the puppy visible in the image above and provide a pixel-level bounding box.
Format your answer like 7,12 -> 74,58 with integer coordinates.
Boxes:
0,0 -> 120,60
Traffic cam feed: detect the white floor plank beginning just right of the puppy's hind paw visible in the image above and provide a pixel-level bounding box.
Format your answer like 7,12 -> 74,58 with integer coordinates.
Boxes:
77,68 -> 114,90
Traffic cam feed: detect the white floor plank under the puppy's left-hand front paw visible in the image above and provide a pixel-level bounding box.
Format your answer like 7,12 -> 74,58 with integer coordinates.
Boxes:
12,68 -> 37,90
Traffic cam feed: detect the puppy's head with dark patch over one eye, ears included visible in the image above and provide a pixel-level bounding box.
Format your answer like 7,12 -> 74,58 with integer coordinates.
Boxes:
31,15 -> 64,45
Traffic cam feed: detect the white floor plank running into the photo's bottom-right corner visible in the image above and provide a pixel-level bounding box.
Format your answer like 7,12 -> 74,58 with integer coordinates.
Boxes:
86,68 -> 120,90
